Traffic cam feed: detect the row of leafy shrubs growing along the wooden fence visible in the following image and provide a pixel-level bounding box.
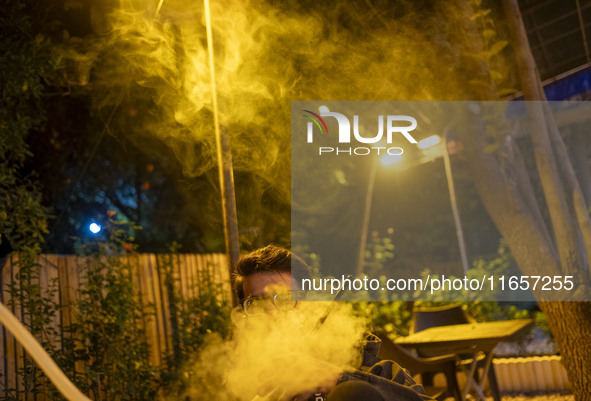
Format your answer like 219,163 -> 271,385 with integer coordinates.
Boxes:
0,216 -> 230,401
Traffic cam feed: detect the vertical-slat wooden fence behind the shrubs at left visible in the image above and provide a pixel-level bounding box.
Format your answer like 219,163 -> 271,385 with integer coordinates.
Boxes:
0,254 -> 232,392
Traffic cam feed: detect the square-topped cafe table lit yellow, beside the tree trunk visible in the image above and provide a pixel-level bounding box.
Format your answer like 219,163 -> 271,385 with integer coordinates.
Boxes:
395,319 -> 533,401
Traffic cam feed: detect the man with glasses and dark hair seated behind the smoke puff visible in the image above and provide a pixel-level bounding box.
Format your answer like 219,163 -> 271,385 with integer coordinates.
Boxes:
234,245 -> 431,401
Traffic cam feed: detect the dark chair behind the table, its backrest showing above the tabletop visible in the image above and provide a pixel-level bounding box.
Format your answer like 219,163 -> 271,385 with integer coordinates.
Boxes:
409,304 -> 501,401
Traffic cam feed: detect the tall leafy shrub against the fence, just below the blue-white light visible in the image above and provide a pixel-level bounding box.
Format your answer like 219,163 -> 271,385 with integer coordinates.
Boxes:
64,222 -> 160,401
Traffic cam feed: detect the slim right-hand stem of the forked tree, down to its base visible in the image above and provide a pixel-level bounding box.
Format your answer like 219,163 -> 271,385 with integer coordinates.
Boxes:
502,0 -> 591,400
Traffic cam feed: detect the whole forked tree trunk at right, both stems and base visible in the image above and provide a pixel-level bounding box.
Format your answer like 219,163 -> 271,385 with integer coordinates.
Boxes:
448,0 -> 591,400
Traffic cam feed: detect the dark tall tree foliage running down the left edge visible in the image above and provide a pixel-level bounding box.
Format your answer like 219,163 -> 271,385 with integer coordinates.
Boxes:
0,0 -> 59,400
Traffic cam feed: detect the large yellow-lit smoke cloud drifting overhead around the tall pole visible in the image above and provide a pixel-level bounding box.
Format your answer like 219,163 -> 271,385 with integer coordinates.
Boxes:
57,0 -> 516,245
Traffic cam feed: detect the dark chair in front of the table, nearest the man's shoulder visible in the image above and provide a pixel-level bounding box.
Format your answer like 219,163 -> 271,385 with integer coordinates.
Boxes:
374,329 -> 462,401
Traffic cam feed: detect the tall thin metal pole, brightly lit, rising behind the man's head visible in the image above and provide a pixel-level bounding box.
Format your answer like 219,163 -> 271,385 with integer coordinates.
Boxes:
204,0 -> 240,305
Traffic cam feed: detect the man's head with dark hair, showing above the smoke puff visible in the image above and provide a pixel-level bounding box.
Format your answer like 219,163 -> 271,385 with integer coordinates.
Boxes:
234,245 -> 310,300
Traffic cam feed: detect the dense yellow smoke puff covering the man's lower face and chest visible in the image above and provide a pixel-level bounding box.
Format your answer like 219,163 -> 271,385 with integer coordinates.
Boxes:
187,302 -> 366,401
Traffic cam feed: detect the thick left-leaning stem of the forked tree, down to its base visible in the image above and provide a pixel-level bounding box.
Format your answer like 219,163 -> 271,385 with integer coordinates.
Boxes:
462,122 -> 591,401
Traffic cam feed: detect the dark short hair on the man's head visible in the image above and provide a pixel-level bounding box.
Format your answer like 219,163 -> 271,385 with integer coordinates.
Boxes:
233,245 -> 310,300
